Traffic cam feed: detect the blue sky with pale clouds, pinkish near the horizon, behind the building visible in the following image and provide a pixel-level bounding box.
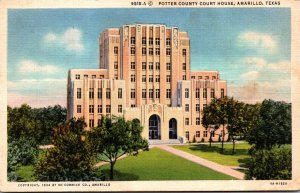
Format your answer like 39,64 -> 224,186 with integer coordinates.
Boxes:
7,8 -> 291,106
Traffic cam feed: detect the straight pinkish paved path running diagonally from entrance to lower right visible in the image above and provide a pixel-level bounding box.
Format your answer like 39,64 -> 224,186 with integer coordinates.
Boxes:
156,145 -> 244,180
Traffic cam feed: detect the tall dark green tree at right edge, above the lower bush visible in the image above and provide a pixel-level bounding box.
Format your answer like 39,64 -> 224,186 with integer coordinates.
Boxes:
247,100 -> 291,149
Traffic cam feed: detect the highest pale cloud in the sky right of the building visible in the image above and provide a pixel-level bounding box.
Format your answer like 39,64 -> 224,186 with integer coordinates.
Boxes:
238,31 -> 278,52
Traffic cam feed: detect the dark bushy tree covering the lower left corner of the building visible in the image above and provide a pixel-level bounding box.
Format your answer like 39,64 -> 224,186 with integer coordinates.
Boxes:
34,118 -> 102,181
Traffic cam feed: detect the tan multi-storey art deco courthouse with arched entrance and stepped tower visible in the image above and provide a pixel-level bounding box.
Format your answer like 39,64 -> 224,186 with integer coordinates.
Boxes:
67,24 -> 227,141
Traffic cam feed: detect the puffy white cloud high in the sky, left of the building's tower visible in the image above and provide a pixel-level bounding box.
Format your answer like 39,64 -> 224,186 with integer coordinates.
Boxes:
43,28 -> 84,53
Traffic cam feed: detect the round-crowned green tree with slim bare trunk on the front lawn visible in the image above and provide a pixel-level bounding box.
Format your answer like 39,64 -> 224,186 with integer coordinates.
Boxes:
88,117 -> 148,180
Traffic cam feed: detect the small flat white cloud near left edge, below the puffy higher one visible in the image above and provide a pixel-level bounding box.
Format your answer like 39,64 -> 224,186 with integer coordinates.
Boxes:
18,60 -> 60,74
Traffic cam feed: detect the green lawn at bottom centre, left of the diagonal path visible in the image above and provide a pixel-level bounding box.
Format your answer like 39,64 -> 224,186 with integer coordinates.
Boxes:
101,148 -> 235,181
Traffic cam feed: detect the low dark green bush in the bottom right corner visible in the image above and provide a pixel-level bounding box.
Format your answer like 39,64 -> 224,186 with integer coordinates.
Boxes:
246,146 -> 292,180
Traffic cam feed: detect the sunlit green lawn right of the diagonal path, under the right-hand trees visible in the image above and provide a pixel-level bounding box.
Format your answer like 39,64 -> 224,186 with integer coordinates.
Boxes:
172,143 -> 251,167
